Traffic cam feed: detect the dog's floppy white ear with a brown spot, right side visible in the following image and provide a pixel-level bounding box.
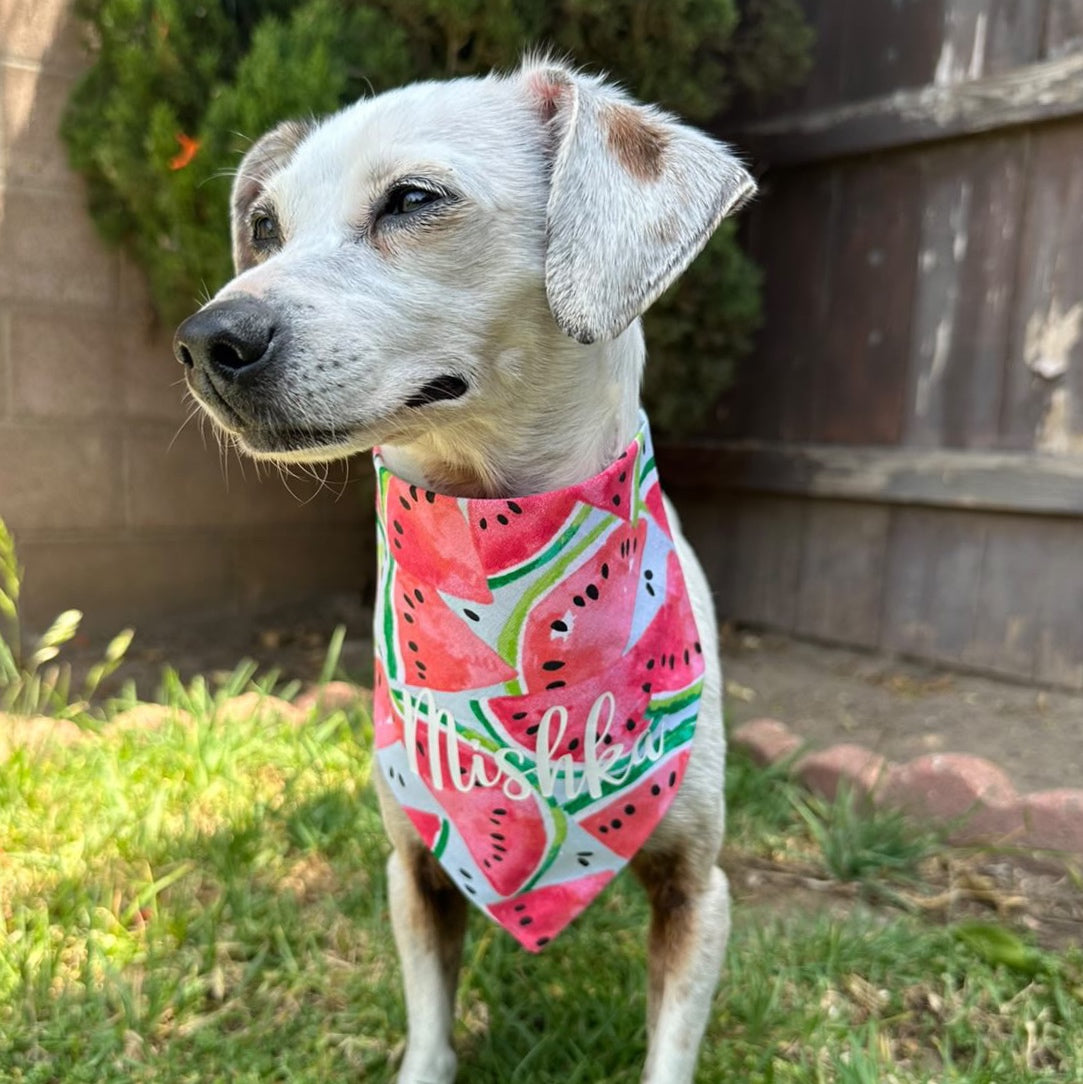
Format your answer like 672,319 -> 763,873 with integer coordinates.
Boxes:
521,65 -> 756,343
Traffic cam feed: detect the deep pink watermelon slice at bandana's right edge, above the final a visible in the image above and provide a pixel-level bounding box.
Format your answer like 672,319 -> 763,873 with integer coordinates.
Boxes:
628,551 -> 704,698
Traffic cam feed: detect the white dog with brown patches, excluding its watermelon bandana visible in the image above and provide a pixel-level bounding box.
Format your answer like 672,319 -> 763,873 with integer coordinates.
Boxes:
175,57 -> 755,1084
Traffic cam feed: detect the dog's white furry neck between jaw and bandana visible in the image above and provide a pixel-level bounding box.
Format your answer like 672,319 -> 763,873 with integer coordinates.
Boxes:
381,321 -> 644,498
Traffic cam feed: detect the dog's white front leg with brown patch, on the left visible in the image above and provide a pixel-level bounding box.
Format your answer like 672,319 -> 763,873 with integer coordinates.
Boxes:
387,846 -> 466,1084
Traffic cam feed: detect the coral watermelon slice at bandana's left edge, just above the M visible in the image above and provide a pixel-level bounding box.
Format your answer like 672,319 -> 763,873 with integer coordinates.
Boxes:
391,565 -> 515,689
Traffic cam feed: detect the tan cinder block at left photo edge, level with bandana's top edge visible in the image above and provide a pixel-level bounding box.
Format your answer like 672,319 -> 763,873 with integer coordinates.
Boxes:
0,424 -> 123,530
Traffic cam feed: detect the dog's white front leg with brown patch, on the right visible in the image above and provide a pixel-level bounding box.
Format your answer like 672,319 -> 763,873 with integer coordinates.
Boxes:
634,854 -> 730,1084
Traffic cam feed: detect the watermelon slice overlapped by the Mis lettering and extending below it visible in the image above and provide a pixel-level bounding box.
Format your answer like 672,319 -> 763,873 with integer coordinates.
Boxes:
408,719 -> 549,895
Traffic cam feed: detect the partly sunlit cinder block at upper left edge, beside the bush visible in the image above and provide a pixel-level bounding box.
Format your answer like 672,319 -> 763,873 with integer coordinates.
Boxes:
0,63 -> 77,188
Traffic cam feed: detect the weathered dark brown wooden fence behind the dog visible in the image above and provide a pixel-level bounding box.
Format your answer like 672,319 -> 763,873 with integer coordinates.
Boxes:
667,0 -> 1083,688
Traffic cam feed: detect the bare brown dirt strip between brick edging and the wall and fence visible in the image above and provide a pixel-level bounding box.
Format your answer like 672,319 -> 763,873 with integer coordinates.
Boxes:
72,595 -> 1083,790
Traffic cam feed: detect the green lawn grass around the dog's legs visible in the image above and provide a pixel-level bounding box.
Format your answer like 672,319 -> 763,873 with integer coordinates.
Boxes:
0,670 -> 1083,1084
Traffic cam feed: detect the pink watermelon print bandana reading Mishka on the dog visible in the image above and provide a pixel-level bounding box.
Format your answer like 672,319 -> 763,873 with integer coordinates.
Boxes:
373,417 -> 704,952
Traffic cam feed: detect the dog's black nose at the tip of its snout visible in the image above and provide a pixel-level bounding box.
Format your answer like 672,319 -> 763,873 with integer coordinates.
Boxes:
173,297 -> 275,380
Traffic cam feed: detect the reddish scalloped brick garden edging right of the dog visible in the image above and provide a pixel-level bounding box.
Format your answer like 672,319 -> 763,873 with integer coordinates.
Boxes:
730,719 -> 1083,857
